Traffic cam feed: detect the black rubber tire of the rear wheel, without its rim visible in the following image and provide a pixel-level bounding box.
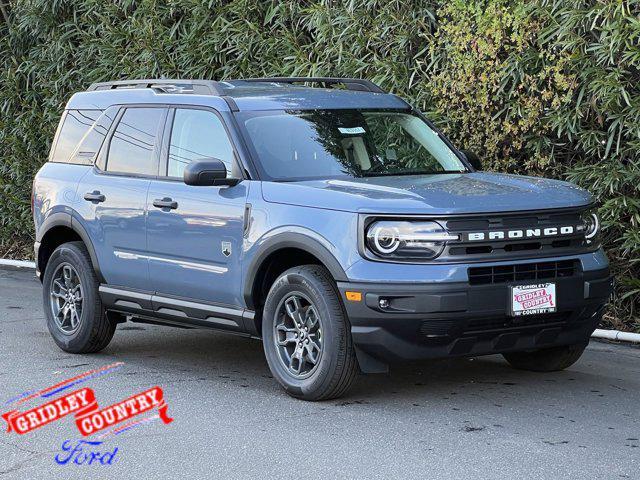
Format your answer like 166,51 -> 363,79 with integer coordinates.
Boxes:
42,242 -> 116,353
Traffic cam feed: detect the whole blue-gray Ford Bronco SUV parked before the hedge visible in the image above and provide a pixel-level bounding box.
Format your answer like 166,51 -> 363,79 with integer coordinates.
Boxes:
33,77 -> 612,400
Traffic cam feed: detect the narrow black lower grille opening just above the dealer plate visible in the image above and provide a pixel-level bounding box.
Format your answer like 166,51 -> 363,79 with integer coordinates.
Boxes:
468,260 -> 578,285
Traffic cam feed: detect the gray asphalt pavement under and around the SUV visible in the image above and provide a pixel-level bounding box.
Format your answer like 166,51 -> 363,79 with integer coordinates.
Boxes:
0,269 -> 640,480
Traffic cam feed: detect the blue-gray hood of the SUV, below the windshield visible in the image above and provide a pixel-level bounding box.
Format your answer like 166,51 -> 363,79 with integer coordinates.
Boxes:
263,172 -> 593,214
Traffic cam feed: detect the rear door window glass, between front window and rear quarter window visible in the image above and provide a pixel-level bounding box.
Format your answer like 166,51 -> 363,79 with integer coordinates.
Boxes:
107,108 -> 164,175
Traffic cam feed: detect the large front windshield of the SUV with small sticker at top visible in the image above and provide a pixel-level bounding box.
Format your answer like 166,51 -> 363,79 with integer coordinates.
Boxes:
238,110 -> 467,181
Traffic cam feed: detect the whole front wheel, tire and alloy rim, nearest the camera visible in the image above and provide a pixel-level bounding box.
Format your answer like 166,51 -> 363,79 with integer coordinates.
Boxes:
262,265 -> 358,401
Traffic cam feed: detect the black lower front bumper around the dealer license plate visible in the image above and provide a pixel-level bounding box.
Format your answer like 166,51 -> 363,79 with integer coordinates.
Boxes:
338,269 -> 613,373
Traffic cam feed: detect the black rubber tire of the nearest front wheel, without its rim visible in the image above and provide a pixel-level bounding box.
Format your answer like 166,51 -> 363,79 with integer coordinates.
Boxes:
262,265 -> 359,401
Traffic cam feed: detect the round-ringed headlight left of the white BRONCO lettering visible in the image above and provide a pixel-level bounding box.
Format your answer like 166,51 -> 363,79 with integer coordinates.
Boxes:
365,220 -> 458,260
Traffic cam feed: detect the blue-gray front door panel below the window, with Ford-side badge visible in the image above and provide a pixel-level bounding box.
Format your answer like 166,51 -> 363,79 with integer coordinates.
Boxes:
147,180 -> 251,306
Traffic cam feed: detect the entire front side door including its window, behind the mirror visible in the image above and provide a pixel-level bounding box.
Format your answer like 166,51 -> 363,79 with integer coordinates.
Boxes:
147,107 -> 249,307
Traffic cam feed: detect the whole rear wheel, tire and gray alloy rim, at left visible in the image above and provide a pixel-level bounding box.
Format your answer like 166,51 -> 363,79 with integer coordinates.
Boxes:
42,242 -> 116,353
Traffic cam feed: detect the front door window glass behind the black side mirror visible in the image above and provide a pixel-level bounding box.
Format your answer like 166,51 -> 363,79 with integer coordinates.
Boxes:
167,109 -> 233,178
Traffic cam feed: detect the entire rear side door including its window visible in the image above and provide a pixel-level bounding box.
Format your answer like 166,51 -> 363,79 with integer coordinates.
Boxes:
78,107 -> 167,291
